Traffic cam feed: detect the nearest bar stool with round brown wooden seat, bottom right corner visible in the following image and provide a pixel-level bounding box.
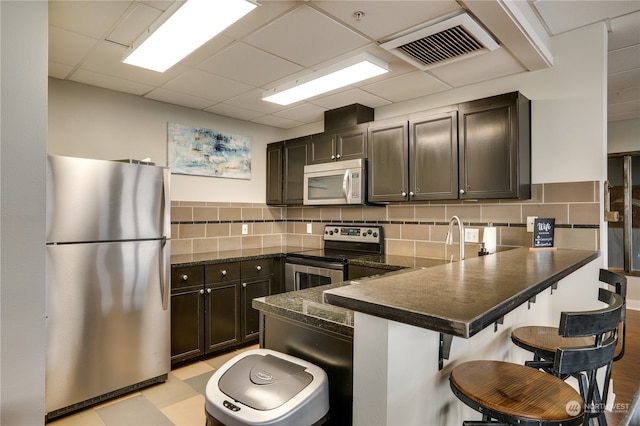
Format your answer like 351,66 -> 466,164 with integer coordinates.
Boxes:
449,289 -> 624,426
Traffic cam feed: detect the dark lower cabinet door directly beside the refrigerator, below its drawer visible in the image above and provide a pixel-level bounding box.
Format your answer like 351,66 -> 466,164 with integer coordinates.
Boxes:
171,286 -> 204,363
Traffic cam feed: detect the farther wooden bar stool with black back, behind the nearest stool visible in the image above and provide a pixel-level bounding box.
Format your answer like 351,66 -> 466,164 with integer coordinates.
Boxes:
511,269 -> 627,418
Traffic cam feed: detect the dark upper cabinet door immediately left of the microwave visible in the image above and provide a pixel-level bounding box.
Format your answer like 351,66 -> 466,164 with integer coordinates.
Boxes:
283,137 -> 309,205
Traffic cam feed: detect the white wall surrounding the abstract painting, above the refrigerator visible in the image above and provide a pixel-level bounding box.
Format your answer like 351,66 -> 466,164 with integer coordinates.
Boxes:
47,78 -> 287,203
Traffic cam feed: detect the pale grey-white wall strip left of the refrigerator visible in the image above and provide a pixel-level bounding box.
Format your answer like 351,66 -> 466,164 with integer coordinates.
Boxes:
0,1 -> 48,425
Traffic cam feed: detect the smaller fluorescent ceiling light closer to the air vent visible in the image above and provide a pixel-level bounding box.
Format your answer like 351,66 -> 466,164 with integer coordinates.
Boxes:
262,53 -> 389,105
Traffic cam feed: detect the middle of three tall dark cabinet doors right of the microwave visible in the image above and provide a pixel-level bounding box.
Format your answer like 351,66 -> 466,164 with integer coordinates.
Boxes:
409,111 -> 458,200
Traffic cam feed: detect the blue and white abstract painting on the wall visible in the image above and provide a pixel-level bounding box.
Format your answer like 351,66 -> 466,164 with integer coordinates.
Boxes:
167,123 -> 251,179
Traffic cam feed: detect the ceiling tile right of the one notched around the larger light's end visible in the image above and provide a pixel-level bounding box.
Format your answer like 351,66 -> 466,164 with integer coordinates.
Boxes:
164,69 -> 252,102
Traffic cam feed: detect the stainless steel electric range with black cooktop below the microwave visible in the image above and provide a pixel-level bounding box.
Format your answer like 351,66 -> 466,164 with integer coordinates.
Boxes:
285,224 -> 384,291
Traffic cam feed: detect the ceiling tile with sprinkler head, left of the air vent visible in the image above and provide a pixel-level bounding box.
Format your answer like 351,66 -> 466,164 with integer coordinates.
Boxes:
314,0 -> 462,41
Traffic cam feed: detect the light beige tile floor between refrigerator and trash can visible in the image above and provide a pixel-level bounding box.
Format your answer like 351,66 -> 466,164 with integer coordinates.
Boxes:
47,345 -> 258,426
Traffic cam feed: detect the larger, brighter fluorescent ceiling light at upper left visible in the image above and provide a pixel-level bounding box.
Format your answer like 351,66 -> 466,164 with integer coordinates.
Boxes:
123,0 -> 258,72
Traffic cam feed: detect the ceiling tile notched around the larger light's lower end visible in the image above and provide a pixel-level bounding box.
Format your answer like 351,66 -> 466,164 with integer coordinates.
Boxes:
82,41 -> 187,86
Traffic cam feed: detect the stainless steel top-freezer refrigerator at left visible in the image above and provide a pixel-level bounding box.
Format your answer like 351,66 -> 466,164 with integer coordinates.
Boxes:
45,156 -> 171,419
